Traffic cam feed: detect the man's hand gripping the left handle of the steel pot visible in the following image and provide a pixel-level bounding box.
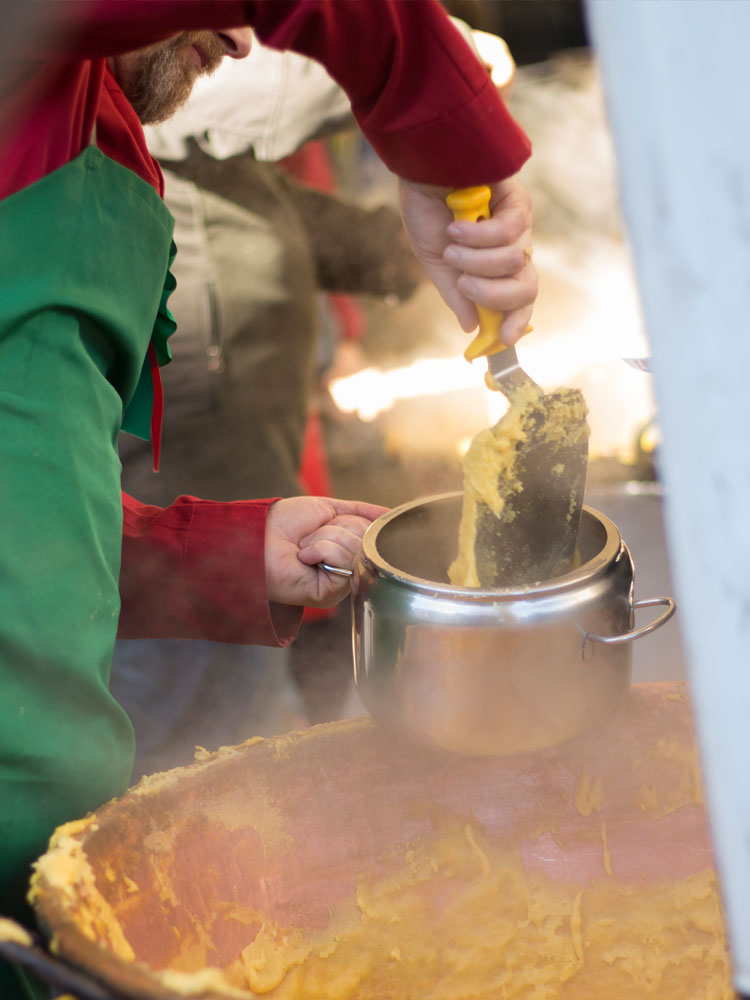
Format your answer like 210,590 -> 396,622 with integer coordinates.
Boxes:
266,497 -> 388,608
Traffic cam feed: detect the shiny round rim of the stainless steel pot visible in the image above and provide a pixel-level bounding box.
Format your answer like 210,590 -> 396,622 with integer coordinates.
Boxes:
362,490 -> 624,603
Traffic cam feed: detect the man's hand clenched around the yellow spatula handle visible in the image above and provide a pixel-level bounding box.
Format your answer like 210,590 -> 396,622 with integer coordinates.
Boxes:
400,178 -> 537,345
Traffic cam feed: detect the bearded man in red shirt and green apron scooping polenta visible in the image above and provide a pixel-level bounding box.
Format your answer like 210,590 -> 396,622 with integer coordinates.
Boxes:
0,0 -> 536,1000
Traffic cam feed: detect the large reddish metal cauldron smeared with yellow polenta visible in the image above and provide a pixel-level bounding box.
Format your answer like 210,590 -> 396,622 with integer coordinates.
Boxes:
0,684 -> 729,1000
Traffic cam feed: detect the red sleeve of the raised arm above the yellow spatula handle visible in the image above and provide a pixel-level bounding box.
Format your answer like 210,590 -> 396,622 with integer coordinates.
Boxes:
248,0 -> 531,187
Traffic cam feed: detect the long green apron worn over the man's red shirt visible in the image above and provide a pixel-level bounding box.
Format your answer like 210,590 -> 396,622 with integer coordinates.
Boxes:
0,146 -> 174,1000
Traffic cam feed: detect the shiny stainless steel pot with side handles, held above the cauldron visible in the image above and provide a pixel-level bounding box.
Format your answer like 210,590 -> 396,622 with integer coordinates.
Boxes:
353,493 -> 675,754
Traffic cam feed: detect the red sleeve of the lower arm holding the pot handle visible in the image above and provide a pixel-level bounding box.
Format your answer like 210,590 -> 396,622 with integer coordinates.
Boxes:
118,493 -> 302,646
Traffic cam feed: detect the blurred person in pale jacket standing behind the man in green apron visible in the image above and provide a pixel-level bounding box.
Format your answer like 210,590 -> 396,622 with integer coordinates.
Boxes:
111,41 -> 421,779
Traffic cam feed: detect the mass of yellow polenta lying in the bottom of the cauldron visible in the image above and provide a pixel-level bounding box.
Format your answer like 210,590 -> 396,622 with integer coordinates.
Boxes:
228,823 -> 733,1000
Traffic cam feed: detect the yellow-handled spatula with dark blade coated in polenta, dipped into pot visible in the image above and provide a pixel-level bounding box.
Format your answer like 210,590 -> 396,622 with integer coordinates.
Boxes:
447,187 -> 589,588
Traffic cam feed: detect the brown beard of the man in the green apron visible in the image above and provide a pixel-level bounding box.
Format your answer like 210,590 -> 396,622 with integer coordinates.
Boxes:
127,31 -> 224,125
